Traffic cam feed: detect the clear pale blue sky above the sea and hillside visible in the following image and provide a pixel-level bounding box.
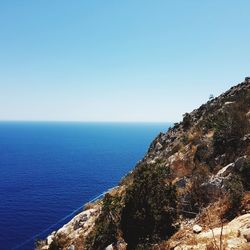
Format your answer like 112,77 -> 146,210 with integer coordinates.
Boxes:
0,0 -> 250,121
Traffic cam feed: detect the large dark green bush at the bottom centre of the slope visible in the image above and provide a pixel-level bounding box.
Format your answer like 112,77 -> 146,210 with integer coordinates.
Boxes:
121,164 -> 177,249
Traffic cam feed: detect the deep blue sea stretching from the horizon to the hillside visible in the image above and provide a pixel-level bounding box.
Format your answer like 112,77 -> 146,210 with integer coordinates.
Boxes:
0,122 -> 169,250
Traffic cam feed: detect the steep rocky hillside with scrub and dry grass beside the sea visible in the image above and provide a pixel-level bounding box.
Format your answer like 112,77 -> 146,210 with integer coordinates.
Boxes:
37,79 -> 250,250
